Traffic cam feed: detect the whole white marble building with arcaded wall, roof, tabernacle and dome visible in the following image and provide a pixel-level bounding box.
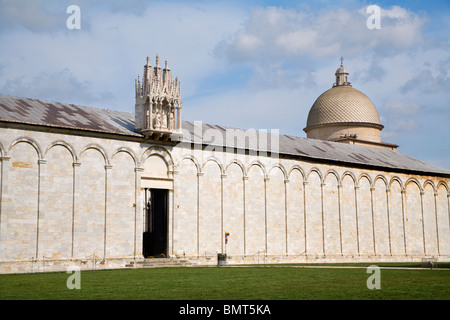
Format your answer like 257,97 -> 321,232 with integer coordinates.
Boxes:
0,59 -> 450,273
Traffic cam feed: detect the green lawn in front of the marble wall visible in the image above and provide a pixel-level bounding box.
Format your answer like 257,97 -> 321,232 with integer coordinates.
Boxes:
0,264 -> 450,300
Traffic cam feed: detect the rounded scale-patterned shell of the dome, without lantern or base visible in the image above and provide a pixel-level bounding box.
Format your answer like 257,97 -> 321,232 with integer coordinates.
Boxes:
306,86 -> 381,128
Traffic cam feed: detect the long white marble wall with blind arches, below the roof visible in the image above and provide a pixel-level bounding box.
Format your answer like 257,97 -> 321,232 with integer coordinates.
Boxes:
0,128 -> 450,273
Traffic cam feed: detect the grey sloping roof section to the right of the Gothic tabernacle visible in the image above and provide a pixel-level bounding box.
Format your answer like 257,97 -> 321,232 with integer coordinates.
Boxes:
183,121 -> 450,175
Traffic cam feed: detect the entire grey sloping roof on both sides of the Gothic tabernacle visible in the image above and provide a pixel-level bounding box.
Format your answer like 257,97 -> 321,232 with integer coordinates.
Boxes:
0,95 -> 450,176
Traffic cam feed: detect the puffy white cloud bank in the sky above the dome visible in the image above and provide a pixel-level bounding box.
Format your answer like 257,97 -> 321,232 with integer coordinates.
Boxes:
216,6 -> 425,61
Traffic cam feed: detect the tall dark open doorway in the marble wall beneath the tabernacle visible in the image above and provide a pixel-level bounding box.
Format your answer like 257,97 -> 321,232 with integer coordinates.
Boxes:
142,188 -> 168,258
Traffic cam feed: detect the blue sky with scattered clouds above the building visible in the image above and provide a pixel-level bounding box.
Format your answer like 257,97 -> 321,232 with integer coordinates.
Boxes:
0,0 -> 450,169
